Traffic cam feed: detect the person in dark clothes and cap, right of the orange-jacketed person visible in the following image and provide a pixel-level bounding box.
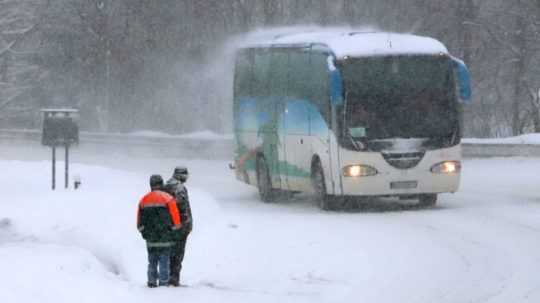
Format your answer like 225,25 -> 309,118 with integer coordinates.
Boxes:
165,166 -> 193,286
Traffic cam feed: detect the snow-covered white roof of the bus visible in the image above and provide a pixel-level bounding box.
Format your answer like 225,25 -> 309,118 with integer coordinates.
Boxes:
245,30 -> 448,59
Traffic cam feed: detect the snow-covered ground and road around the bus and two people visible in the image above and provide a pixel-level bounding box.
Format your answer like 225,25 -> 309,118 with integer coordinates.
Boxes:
0,143 -> 540,303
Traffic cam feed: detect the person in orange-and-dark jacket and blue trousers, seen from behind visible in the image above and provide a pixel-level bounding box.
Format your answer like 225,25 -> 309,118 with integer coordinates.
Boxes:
137,175 -> 182,287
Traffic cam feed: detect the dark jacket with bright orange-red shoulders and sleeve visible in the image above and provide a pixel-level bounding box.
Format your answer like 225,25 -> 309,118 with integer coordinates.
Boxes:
137,190 -> 182,247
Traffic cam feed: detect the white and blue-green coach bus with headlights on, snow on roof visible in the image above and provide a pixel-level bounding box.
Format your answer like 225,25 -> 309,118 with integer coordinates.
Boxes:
233,32 -> 470,210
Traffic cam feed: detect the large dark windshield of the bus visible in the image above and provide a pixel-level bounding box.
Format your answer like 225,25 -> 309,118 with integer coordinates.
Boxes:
341,55 -> 459,149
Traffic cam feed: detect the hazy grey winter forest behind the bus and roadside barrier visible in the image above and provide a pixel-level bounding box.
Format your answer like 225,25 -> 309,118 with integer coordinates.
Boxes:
0,0 -> 540,137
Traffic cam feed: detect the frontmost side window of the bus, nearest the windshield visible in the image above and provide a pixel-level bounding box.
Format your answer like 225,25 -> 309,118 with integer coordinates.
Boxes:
310,52 -> 330,121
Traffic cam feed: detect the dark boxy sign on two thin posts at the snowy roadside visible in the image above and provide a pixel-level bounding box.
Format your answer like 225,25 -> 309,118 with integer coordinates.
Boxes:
41,109 -> 79,190
